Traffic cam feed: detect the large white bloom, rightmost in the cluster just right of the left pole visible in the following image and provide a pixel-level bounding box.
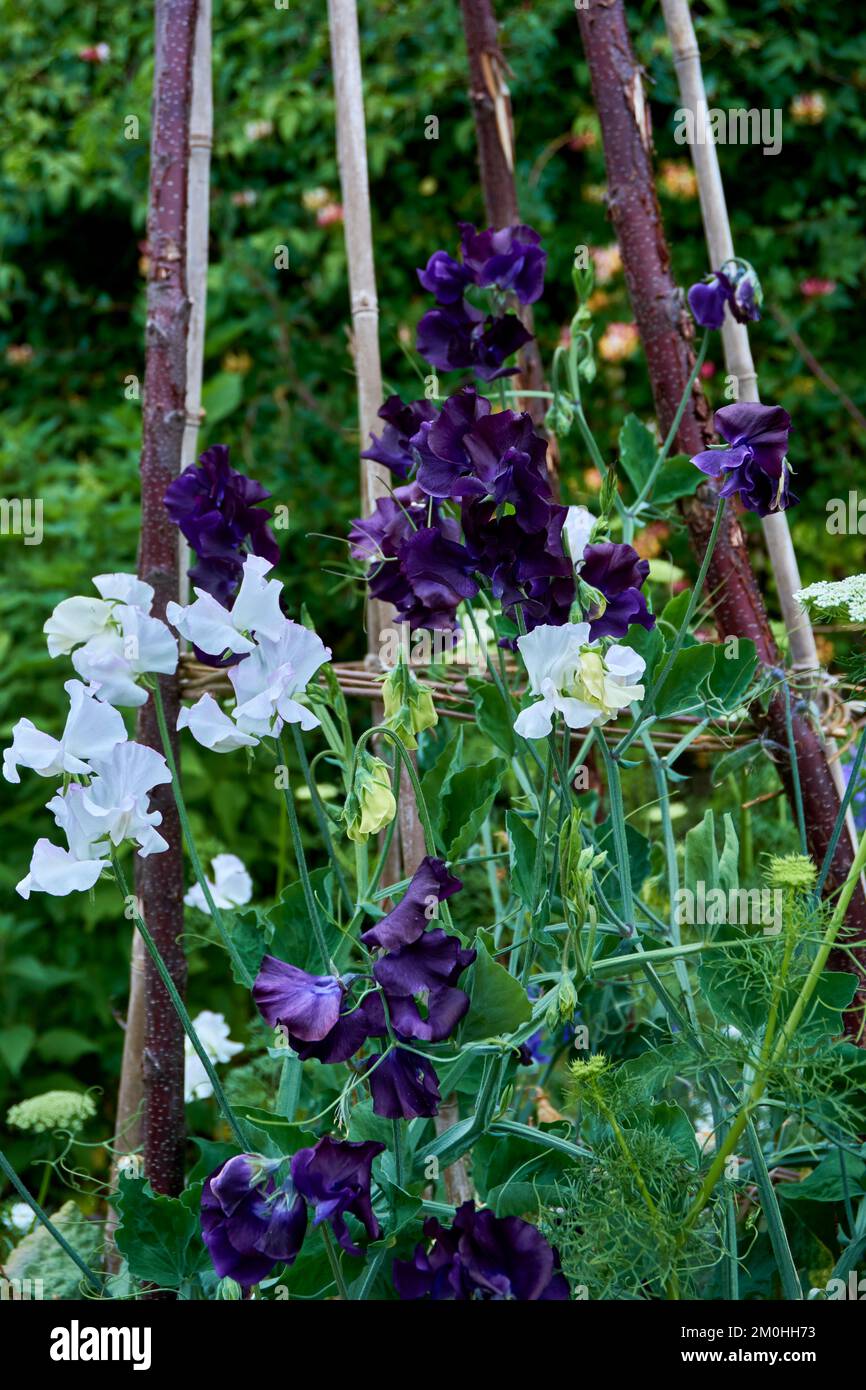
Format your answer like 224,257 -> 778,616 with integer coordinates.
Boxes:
228,619 -> 331,738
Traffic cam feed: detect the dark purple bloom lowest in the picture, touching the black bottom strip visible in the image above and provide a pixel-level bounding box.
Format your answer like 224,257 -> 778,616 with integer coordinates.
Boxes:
393,1201 -> 571,1302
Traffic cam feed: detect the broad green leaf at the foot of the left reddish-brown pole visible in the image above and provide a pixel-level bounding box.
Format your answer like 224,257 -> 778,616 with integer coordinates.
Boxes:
115,1175 -> 210,1289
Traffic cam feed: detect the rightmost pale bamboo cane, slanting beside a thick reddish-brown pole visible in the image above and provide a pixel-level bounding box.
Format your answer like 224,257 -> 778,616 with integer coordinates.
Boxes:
662,0 -> 856,844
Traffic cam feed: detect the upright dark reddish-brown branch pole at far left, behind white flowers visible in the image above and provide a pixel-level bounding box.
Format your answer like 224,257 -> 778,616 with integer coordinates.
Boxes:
135,0 -> 197,1194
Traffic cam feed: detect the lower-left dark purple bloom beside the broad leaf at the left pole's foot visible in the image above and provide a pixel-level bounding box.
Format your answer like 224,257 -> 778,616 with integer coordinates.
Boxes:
202,1154 -> 307,1289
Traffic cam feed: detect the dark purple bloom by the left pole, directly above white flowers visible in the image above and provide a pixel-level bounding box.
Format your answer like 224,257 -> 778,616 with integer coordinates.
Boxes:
164,443 -> 279,605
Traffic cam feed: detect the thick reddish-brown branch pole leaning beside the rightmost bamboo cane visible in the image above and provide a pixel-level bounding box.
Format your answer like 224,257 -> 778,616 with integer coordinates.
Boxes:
577,0 -> 866,995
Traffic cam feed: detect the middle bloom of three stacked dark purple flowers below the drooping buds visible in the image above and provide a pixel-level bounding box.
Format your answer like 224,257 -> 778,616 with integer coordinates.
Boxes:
373,927 -> 477,1043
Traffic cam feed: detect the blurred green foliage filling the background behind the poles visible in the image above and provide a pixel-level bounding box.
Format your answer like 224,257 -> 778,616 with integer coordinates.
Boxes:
0,0 -> 866,1195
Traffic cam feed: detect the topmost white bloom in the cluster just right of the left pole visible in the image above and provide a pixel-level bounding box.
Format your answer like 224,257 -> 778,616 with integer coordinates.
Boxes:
165,555 -> 285,656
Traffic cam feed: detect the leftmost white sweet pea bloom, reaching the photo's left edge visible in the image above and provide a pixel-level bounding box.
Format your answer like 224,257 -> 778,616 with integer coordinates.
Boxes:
3,681 -> 126,783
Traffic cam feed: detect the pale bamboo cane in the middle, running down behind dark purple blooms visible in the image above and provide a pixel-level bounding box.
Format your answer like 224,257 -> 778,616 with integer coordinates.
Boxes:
328,0 -> 424,881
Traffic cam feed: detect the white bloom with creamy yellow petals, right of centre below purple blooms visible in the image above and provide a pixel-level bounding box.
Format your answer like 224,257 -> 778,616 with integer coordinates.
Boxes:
514,623 -> 645,738
